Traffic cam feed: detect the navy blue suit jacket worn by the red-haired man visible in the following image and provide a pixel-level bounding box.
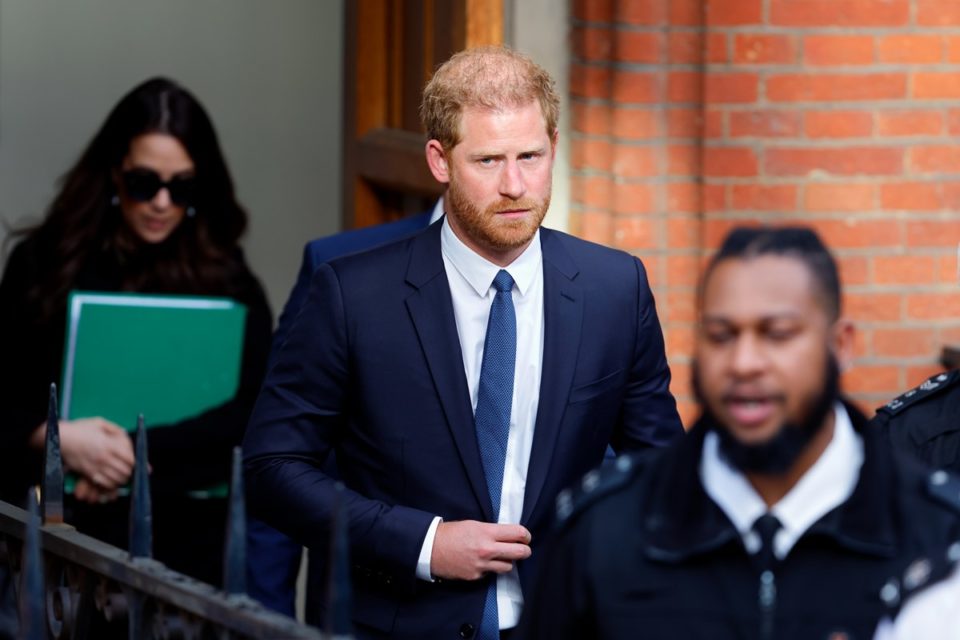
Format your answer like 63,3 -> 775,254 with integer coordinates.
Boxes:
244,223 -> 682,638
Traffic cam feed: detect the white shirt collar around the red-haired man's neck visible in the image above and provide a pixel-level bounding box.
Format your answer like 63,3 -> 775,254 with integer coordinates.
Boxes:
440,217 -> 542,298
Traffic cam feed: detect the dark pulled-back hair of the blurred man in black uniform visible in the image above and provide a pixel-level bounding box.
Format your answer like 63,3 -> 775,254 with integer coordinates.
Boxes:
700,227 -> 840,321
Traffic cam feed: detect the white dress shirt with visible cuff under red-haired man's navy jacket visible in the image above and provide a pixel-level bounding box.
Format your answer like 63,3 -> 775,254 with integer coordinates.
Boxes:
417,220 -> 543,629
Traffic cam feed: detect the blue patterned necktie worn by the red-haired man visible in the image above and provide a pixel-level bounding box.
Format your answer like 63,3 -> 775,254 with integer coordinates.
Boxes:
473,269 -> 517,640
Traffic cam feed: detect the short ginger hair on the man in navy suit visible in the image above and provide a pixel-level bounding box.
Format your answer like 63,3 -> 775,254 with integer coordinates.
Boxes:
420,47 -> 560,150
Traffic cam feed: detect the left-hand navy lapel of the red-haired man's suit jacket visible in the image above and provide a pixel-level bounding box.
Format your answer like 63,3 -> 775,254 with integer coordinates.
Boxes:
406,223 -> 496,522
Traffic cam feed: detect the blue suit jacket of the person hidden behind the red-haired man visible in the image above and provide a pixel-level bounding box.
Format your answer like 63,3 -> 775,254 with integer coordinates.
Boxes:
247,211 -> 431,624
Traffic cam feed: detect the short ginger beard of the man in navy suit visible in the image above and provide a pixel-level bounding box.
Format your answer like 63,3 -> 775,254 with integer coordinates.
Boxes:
446,170 -> 550,253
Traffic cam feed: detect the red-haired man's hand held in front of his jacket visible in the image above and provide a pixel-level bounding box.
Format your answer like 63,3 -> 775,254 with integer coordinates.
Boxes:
430,520 -> 530,580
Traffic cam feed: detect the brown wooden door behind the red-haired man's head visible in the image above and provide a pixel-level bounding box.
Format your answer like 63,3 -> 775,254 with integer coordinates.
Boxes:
343,0 -> 506,229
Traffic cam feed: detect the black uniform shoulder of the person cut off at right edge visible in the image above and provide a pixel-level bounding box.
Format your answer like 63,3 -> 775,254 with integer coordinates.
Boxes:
872,371 -> 960,473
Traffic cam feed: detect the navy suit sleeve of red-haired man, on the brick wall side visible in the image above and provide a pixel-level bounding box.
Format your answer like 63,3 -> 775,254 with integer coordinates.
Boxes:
611,258 -> 683,453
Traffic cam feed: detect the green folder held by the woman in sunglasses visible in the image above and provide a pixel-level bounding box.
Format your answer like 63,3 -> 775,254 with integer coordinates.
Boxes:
60,291 -> 247,496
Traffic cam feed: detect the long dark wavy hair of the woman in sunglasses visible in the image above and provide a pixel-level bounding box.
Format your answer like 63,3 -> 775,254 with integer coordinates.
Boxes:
21,78 -> 247,317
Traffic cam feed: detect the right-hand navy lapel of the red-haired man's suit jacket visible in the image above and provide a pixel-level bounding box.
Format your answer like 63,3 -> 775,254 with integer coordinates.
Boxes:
521,228 -> 583,522
